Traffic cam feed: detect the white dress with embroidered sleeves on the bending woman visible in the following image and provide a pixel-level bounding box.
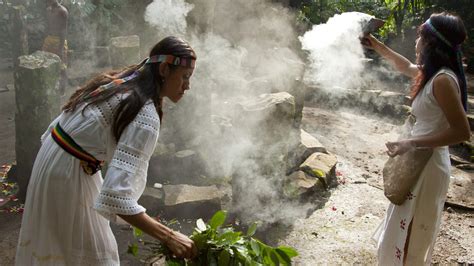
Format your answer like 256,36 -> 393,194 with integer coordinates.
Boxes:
15,92 -> 160,266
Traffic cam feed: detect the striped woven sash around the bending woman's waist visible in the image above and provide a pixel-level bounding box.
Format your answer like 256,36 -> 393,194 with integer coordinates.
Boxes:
51,123 -> 104,175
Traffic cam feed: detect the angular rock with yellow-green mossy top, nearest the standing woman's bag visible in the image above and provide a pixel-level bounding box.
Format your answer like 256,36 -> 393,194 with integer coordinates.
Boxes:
300,152 -> 337,187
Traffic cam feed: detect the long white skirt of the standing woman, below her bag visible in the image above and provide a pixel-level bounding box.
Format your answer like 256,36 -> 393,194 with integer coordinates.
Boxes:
374,147 -> 451,265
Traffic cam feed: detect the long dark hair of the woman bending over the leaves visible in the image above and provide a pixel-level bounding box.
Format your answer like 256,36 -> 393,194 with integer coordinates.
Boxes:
62,36 -> 196,141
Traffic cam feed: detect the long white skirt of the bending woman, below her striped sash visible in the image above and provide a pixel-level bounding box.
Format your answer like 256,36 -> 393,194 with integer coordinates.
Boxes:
15,136 -> 119,266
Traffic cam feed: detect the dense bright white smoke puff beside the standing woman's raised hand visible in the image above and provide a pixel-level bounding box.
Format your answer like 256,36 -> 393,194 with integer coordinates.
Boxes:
300,12 -> 372,89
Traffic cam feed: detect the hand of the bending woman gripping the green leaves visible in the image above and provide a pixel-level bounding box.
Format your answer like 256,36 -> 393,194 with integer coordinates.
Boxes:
164,230 -> 198,259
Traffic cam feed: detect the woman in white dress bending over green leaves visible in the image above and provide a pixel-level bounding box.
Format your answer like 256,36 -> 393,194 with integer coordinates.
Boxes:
16,37 -> 196,266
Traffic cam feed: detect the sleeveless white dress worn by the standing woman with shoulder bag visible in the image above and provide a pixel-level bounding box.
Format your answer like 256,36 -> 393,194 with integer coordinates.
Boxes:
374,69 -> 459,265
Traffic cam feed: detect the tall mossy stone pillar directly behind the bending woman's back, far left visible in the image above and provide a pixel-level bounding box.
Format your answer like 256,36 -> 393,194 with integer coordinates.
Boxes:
14,51 -> 61,198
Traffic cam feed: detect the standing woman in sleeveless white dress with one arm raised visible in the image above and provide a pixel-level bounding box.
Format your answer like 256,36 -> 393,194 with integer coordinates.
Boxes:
364,13 -> 470,265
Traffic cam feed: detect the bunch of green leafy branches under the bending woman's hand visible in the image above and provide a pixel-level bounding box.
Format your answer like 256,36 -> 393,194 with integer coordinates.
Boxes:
129,211 -> 298,266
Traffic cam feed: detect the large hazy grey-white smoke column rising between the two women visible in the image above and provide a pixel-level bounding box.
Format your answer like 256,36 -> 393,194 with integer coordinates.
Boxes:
147,0 -> 308,222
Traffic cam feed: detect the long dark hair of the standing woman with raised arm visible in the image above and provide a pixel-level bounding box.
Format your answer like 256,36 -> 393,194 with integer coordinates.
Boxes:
411,12 -> 467,109
